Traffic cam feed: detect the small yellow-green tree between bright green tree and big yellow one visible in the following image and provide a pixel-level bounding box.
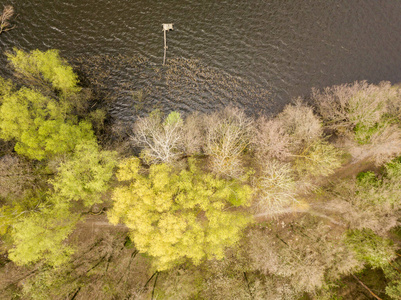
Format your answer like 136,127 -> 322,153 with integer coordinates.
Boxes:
51,142 -> 117,206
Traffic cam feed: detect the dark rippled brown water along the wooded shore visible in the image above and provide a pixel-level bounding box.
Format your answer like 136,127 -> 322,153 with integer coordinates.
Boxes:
0,0 -> 401,121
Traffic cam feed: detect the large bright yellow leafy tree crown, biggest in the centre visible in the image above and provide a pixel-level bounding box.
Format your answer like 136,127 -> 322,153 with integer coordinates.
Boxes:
109,158 -> 252,270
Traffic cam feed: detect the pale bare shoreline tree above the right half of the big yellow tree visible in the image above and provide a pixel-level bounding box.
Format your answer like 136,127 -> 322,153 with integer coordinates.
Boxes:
205,107 -> 253,177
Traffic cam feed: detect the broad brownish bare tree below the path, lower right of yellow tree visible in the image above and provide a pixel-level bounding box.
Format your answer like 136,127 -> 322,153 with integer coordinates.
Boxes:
246,216 -> 361,293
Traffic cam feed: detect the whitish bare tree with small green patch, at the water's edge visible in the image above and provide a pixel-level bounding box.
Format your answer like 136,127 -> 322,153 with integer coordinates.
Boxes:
131,111 -> 184,164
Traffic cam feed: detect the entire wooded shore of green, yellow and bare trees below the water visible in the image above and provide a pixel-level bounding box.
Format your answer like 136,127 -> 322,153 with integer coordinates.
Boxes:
0,49 -> 401,300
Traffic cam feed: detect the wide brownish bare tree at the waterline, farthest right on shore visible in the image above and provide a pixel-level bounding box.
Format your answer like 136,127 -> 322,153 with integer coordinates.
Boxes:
312,81 -> 401,165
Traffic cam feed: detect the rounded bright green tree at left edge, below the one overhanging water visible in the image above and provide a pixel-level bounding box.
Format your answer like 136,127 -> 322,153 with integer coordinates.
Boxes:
0,87 -> 94,160
